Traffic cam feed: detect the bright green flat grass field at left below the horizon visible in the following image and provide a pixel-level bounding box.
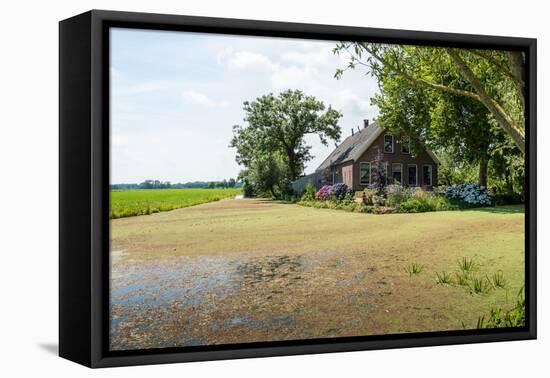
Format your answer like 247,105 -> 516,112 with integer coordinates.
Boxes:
109,188 -> 241,219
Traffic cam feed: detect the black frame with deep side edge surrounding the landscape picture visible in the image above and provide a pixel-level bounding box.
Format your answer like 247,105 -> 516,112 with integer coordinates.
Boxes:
59,10 -> 537,368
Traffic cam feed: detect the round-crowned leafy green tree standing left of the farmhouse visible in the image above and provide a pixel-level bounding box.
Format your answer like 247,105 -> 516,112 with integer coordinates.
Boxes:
230,90 -> 342,196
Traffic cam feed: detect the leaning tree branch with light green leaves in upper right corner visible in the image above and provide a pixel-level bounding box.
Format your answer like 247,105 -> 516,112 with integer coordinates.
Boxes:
334,42 -> 525,153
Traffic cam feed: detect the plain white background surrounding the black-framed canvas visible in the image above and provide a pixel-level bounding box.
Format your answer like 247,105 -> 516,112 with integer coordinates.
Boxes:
0,0 -> 550,378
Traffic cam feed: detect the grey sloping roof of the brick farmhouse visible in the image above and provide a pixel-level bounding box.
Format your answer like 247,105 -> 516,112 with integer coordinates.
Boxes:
316,122 -> 439,172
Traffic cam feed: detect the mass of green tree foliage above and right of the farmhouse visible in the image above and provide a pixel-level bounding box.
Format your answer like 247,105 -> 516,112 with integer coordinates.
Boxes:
334,43 -> 525,194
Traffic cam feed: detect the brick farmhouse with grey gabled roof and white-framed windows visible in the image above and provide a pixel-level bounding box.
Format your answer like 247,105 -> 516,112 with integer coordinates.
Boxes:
293,120 -> 439,192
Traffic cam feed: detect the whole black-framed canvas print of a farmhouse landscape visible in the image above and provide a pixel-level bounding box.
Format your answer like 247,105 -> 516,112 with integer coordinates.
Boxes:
59,10 -> 536,367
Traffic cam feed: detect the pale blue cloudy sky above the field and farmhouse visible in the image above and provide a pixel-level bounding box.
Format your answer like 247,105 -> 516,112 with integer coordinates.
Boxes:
110,28 -> 378,184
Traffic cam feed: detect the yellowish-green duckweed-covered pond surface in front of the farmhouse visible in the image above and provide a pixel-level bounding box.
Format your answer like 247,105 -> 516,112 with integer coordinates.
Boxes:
111,199 -> 524,349
